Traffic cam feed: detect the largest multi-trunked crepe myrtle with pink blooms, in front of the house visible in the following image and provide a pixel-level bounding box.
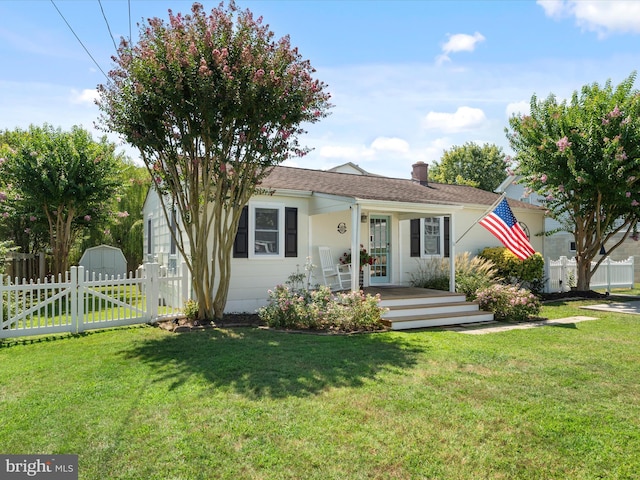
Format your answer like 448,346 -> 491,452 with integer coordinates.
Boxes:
98,2 -> 330,320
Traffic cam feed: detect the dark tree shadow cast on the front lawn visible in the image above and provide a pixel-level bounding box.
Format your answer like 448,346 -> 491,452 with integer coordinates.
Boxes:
122,328 -> 426,398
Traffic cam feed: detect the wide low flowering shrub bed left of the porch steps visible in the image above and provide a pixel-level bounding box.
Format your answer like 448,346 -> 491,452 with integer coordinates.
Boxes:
258,285 -> 384,331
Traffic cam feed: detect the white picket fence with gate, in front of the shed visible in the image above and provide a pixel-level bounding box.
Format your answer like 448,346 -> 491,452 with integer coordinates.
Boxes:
0,263 -> 190,338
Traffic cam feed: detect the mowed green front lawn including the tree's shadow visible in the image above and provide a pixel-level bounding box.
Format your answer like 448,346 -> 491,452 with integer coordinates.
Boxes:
0,301 -> 640,480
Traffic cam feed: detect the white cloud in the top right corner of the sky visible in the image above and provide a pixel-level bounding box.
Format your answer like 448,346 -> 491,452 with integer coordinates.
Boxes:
537,0 -> 640,38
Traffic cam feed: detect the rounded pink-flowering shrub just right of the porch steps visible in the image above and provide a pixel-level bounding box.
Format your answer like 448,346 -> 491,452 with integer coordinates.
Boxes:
476,284 -> 540,322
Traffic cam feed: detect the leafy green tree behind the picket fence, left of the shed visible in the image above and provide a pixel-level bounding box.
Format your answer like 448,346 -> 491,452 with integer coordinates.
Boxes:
0,125 -> 120,274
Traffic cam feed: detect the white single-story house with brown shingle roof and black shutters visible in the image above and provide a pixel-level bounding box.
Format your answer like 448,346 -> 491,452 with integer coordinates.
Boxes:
143,162 -> 544,313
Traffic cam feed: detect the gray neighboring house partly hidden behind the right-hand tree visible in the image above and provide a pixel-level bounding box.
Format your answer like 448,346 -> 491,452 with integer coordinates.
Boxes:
495,175 -> 640,278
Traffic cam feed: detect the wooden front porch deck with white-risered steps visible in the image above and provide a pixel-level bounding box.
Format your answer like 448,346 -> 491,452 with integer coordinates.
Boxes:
364,285 -> 493,330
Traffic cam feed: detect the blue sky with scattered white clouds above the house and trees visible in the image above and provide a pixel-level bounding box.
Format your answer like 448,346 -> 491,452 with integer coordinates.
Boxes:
0,0 -> 640,178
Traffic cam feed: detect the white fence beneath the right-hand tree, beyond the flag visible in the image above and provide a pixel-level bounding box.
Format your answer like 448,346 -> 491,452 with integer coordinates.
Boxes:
545,257 -> 634,293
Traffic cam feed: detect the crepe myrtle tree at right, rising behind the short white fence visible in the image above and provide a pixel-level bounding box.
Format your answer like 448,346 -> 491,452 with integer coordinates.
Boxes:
506,72 -> 640,291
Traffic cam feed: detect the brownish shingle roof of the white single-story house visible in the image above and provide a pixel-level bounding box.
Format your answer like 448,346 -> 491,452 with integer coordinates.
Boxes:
262,166 -> 540,209
